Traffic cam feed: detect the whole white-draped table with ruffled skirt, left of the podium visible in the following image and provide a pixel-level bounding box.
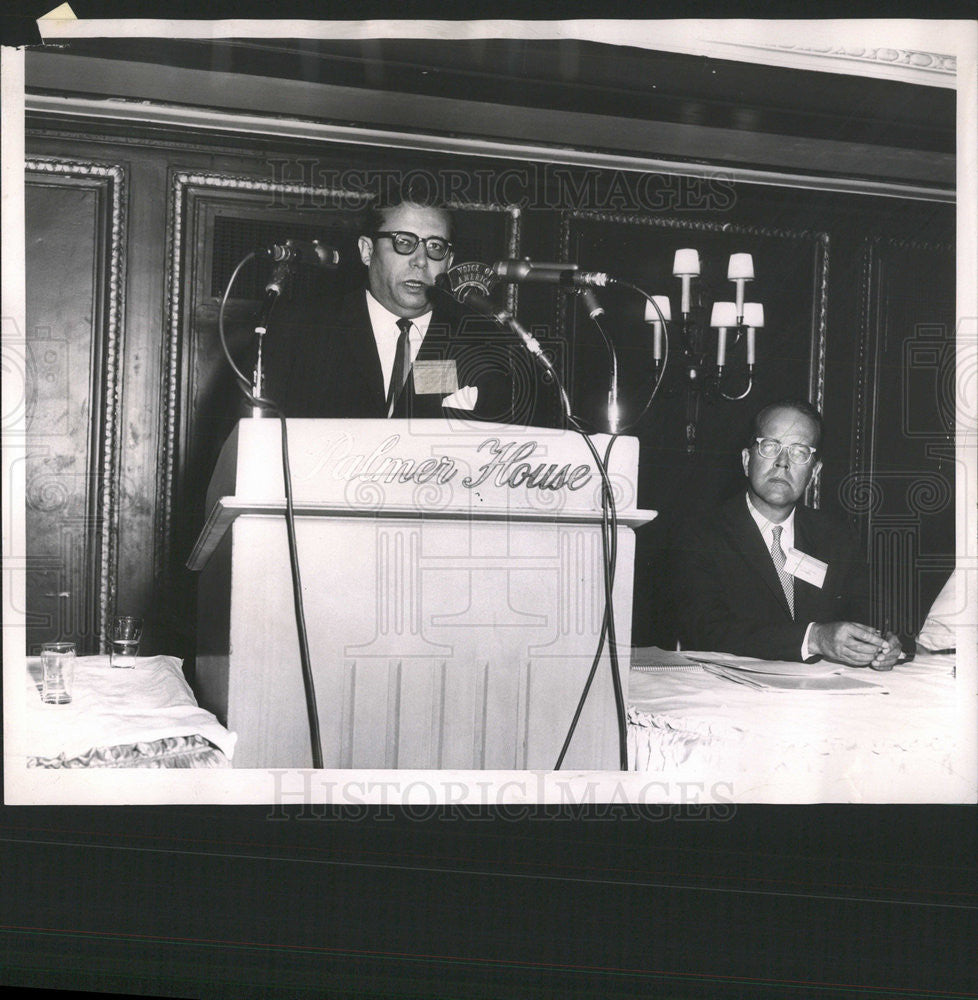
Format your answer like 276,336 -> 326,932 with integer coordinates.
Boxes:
24,656 -> 237,768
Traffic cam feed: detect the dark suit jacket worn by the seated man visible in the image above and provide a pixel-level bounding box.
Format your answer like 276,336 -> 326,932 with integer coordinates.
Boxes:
675,493 -> 878,660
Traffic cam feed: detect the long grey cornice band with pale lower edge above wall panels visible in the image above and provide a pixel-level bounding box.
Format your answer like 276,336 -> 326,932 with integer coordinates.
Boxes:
26,51 -> 955,201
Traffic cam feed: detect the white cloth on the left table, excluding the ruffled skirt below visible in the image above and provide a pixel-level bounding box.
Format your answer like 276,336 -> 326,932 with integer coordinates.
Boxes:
26,656 -> 237,758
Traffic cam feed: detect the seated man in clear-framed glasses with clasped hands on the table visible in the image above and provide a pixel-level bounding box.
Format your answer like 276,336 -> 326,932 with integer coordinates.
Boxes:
676,400 -> 901,670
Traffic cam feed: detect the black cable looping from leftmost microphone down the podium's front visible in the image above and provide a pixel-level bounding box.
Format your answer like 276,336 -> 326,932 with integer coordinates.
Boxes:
217,251 -> 323,770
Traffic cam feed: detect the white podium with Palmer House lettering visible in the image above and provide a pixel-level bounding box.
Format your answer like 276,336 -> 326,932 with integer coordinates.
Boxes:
188,418 -> 655,770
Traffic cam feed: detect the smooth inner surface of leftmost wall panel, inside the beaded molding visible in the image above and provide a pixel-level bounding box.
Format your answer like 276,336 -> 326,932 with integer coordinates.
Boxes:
25,174 -> 106,652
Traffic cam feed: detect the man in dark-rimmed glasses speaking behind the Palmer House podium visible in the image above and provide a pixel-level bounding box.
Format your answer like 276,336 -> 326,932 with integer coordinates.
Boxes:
265,184 -> 513,422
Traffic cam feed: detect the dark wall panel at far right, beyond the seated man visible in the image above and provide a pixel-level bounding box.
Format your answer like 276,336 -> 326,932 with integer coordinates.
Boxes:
840,238 -> 956,633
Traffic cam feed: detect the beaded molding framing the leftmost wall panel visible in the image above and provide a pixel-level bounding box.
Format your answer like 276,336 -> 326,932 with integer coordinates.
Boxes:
24,157 -> 127,636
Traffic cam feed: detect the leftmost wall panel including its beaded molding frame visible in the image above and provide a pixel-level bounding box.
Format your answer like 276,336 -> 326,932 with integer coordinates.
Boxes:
25,158 -> 127,652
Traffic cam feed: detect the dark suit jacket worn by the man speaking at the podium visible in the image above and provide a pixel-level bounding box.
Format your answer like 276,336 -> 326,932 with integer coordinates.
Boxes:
264,289 -> 514,422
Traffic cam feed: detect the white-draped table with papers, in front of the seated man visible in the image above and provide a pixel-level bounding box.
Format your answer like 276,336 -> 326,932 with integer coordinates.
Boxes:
628,652 -> 978,803
